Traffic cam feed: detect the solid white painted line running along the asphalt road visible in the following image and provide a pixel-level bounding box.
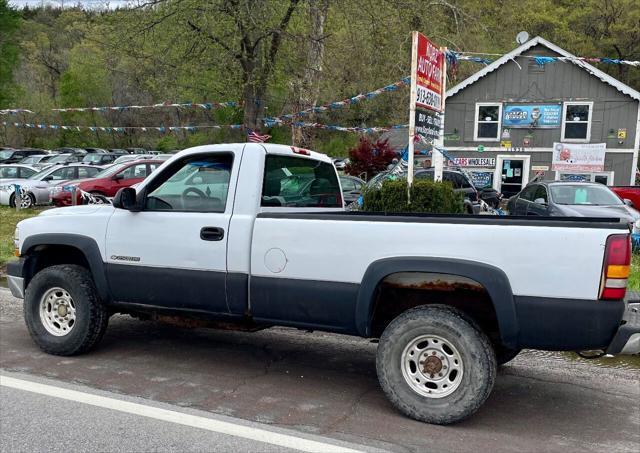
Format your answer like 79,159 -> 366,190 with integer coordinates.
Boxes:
0,375 -> 359,453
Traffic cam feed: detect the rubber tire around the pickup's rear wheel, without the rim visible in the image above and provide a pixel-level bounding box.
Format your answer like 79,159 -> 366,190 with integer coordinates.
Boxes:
376,305 -> 497,425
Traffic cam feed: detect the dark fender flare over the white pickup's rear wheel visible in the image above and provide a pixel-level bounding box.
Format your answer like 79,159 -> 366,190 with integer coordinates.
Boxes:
355,257 -> 519,347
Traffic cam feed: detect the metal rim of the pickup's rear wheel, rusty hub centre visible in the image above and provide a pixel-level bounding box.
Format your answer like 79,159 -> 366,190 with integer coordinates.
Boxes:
401,335 -> 464,398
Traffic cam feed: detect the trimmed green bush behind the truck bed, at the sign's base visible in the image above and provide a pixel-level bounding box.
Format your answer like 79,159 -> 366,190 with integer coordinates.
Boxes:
363,179 -> 464,214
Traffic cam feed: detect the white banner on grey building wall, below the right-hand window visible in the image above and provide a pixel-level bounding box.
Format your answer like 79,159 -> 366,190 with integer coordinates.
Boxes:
551,143 -> 607,171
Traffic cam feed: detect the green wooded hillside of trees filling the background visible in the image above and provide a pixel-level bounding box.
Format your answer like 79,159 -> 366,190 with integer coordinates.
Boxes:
0,0 -> 640,150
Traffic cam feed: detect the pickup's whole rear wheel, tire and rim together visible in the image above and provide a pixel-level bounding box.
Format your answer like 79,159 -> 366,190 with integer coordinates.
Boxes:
376,306 -> 497,425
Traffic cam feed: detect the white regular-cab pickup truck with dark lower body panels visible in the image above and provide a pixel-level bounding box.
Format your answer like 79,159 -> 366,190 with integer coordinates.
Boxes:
7,143 -> 640,424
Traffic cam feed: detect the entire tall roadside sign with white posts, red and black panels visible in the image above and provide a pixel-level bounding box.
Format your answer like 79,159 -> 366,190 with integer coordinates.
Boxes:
407,31 -> 446,187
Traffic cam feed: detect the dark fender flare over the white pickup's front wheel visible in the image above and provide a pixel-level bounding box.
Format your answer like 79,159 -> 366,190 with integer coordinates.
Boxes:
22,233 -> 111,302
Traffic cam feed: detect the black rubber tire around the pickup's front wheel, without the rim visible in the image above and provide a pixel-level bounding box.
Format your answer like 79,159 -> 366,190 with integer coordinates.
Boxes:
24,264 -> 109,356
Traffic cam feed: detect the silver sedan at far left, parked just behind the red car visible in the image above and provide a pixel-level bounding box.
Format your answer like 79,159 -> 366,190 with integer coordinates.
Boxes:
0,164 -> 103,208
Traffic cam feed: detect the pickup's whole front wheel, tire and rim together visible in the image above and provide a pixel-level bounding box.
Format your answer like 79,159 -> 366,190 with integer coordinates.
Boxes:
24,264 -> 109,356
